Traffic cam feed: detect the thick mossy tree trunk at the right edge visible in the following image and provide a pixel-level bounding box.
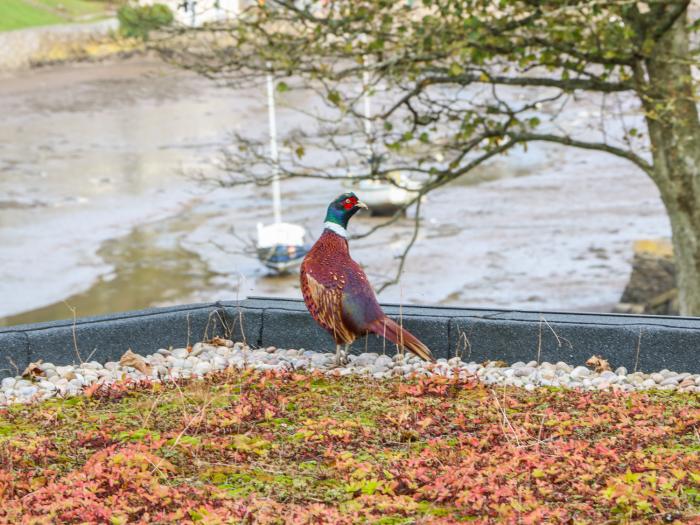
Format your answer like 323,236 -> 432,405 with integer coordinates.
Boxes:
636,13 -> 700,316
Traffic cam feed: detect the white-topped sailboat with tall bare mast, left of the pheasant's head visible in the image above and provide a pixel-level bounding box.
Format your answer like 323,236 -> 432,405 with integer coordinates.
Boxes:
256,69 -> 309,273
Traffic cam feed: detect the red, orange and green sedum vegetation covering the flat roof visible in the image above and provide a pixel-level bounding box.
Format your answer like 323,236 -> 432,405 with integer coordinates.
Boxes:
0,371 -> 700,524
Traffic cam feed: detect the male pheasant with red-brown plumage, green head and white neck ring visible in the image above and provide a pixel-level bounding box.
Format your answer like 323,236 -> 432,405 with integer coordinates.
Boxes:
301,193 -> 435,365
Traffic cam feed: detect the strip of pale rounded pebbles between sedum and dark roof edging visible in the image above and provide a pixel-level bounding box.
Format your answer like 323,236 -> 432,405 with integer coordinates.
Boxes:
0,339 -> 700,406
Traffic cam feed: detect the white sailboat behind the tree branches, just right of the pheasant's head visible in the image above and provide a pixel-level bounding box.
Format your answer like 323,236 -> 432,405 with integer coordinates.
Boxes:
345,65 -> 421,215
